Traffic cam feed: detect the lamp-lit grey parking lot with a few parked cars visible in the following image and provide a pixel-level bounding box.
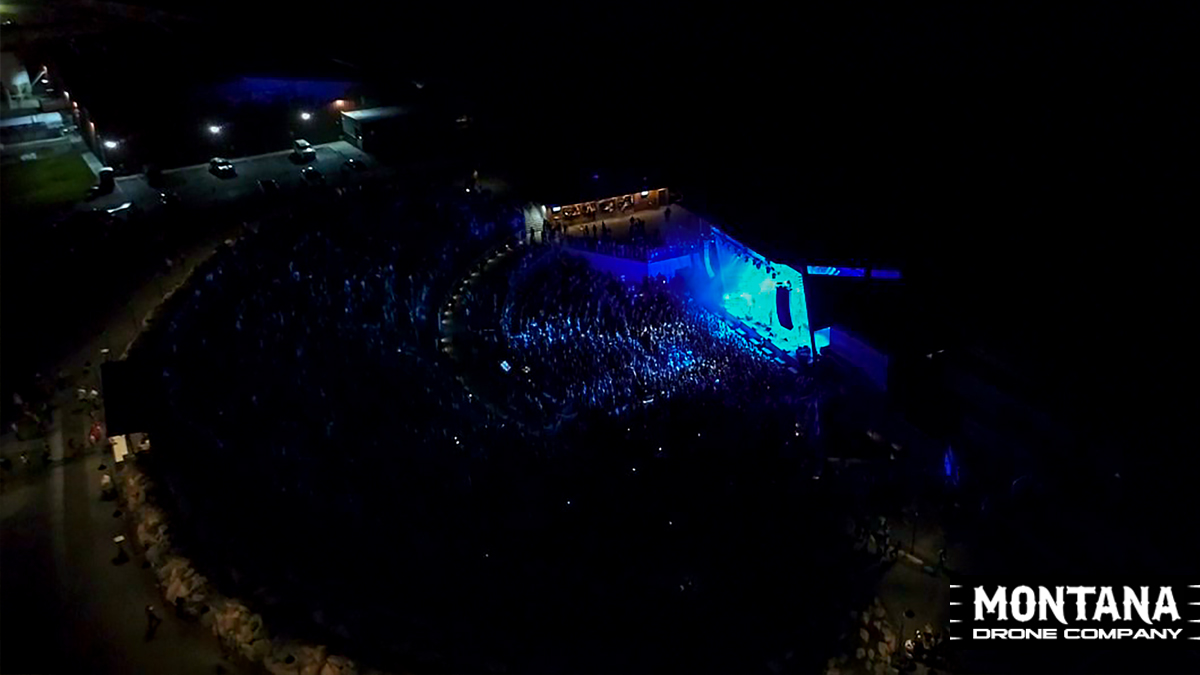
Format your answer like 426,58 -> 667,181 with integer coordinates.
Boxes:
84,141 -> 385,211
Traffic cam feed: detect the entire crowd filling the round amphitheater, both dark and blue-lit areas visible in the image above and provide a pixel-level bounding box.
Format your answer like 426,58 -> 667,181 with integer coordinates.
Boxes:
130,181 -> 854,670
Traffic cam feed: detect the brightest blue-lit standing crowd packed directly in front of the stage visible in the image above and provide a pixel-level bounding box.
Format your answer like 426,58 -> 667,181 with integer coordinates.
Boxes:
503,252 -> 803,413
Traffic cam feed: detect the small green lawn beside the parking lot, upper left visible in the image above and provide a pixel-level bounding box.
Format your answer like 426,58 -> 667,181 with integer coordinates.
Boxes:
0,153 -> 96,210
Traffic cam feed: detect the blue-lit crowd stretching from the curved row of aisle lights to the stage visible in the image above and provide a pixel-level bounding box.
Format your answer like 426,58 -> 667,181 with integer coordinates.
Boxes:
454,241 -> 816,451
